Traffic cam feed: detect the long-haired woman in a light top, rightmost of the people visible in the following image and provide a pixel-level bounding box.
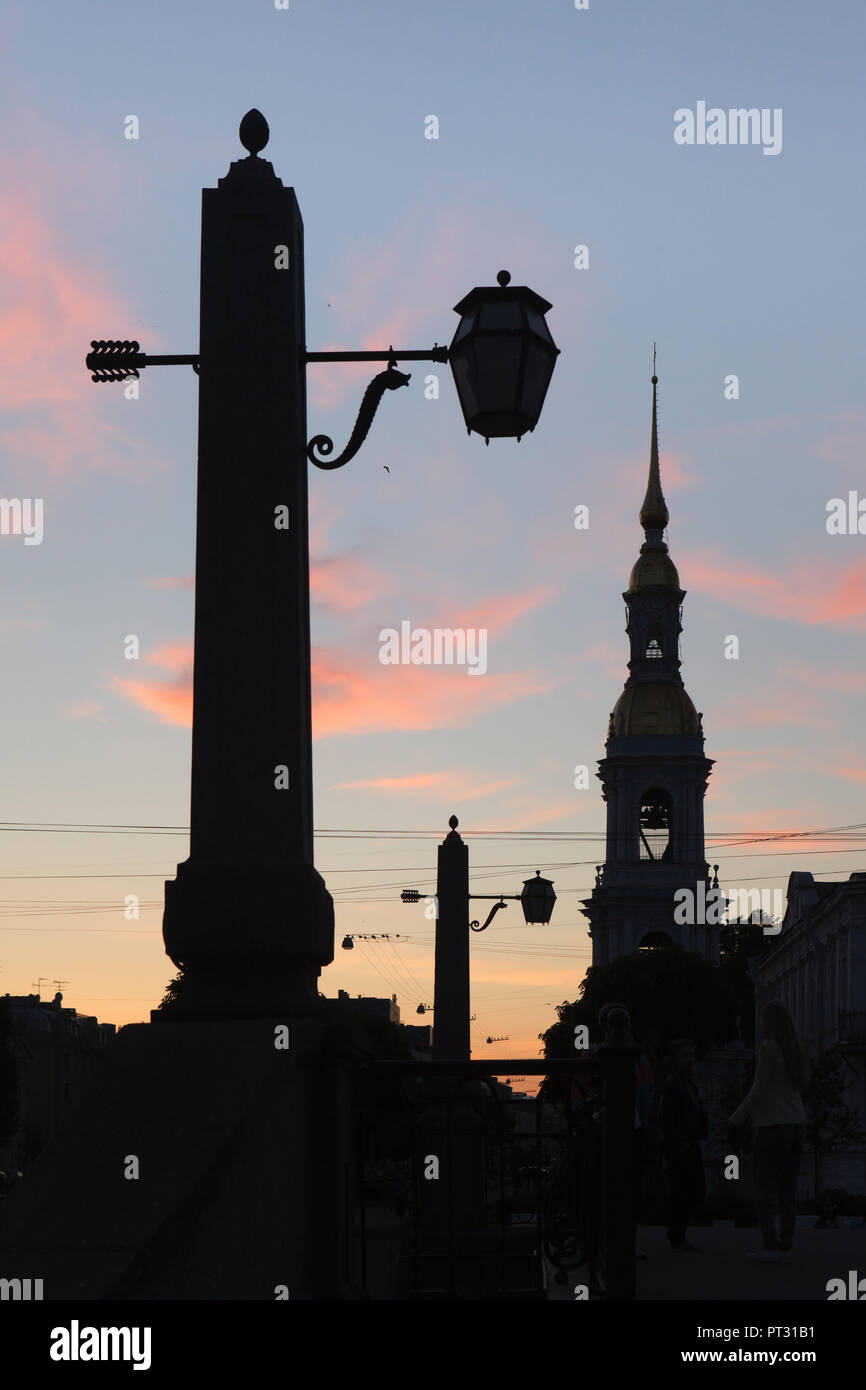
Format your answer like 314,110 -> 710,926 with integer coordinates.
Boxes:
731,1001 -> 809,1264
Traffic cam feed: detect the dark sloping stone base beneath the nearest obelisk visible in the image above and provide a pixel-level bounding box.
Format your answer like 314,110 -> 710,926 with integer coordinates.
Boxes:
0,1016 -> 357,1301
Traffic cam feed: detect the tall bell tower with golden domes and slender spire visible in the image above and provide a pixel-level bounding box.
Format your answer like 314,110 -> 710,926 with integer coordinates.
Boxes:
582,375 -> 719,965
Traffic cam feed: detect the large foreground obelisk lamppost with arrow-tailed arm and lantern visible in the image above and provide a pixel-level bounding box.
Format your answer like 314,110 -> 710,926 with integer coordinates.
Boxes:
85,110 -> 557,1019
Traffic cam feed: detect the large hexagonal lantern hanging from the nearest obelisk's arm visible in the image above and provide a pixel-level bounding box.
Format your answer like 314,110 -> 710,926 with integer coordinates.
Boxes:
448,270 -> 559,443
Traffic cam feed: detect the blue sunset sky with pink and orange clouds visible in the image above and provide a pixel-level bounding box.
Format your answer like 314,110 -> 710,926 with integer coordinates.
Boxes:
0,0 -> 866,1056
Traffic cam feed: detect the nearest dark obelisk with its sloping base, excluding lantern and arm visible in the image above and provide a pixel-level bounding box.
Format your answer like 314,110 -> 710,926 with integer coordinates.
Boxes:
0,113 -> 356,1300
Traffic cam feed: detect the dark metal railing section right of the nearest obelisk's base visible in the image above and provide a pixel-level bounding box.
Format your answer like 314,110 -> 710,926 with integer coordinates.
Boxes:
356,1048 -> 635,1300
